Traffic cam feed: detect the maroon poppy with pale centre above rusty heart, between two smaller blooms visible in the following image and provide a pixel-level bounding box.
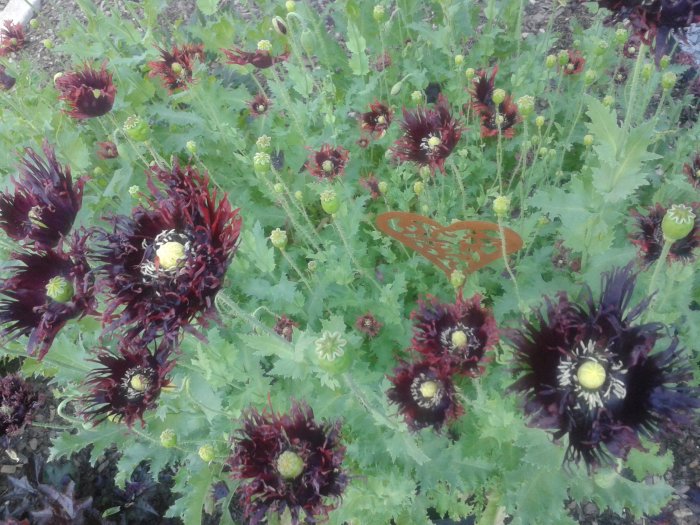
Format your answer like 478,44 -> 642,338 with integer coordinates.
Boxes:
392,95 -> 463,174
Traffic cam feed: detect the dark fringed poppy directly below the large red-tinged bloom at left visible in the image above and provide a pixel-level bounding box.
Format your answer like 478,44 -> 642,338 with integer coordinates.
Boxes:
83,339 -> 175,427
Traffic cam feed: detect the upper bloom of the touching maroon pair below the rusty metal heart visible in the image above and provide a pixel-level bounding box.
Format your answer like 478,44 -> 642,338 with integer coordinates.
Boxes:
411,293 -> 498,376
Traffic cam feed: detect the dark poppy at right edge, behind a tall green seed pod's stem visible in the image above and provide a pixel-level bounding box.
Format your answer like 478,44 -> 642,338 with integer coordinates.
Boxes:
630,202 -> 700,266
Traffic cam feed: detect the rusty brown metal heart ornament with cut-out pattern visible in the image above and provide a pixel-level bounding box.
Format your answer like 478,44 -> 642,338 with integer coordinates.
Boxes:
377,211 -> 523,277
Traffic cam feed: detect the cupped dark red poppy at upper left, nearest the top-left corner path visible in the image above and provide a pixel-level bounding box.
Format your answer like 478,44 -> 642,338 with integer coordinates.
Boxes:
56,63 -> 117,119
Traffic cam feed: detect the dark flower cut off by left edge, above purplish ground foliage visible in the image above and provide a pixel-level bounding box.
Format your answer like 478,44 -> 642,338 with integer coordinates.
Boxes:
0,374 -> 42,443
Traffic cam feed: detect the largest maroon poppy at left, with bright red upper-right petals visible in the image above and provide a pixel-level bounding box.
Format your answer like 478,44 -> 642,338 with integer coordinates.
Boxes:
94,161 -> 241,342
